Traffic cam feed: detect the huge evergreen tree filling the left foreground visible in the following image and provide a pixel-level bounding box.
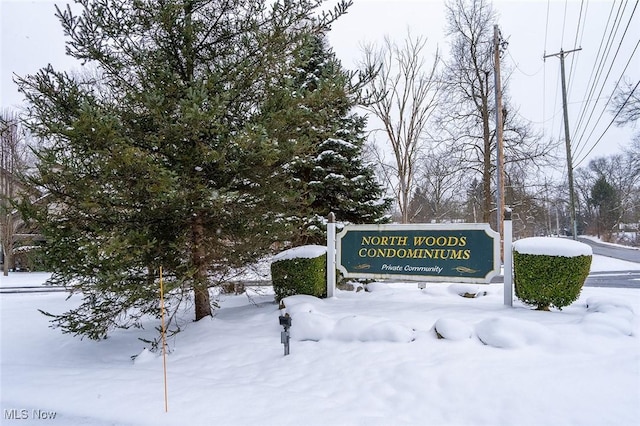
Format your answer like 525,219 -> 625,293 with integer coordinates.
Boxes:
20,0 -> 350,339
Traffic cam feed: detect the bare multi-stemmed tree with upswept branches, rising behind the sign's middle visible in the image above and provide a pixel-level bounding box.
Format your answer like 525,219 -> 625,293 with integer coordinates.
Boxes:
363,34 -> 440,223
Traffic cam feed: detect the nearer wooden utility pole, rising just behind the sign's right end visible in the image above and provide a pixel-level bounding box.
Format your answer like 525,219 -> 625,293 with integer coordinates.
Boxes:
493,25 -> 504,253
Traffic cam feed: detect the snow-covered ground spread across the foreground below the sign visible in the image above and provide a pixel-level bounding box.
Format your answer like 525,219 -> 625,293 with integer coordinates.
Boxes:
0,256 -> 640,426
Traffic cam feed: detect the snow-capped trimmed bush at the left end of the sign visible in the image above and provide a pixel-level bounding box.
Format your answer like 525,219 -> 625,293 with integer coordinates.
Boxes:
271,245 -> 327,302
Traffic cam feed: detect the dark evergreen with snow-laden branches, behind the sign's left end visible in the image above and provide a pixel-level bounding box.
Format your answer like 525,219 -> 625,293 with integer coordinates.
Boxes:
266,34 -> 392,244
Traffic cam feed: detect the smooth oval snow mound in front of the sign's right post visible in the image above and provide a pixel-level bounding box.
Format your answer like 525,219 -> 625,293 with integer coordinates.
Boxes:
476,318 -> 552,349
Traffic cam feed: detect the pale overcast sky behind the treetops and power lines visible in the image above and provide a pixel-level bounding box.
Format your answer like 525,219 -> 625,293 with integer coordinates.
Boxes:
0,0 -> 640,166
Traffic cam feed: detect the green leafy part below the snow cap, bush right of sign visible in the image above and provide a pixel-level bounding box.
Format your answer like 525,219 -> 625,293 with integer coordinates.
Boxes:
513,239 -> 592,310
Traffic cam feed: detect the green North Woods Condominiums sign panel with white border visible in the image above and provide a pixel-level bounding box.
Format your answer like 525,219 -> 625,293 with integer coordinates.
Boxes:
336,223 -> 500,283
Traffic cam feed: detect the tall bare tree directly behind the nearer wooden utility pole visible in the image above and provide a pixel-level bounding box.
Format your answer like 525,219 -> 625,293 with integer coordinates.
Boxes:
438,0 -> 553,228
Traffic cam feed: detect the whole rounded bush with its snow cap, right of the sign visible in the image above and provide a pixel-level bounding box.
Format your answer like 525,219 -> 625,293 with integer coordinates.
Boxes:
513,237 -> 592,310
